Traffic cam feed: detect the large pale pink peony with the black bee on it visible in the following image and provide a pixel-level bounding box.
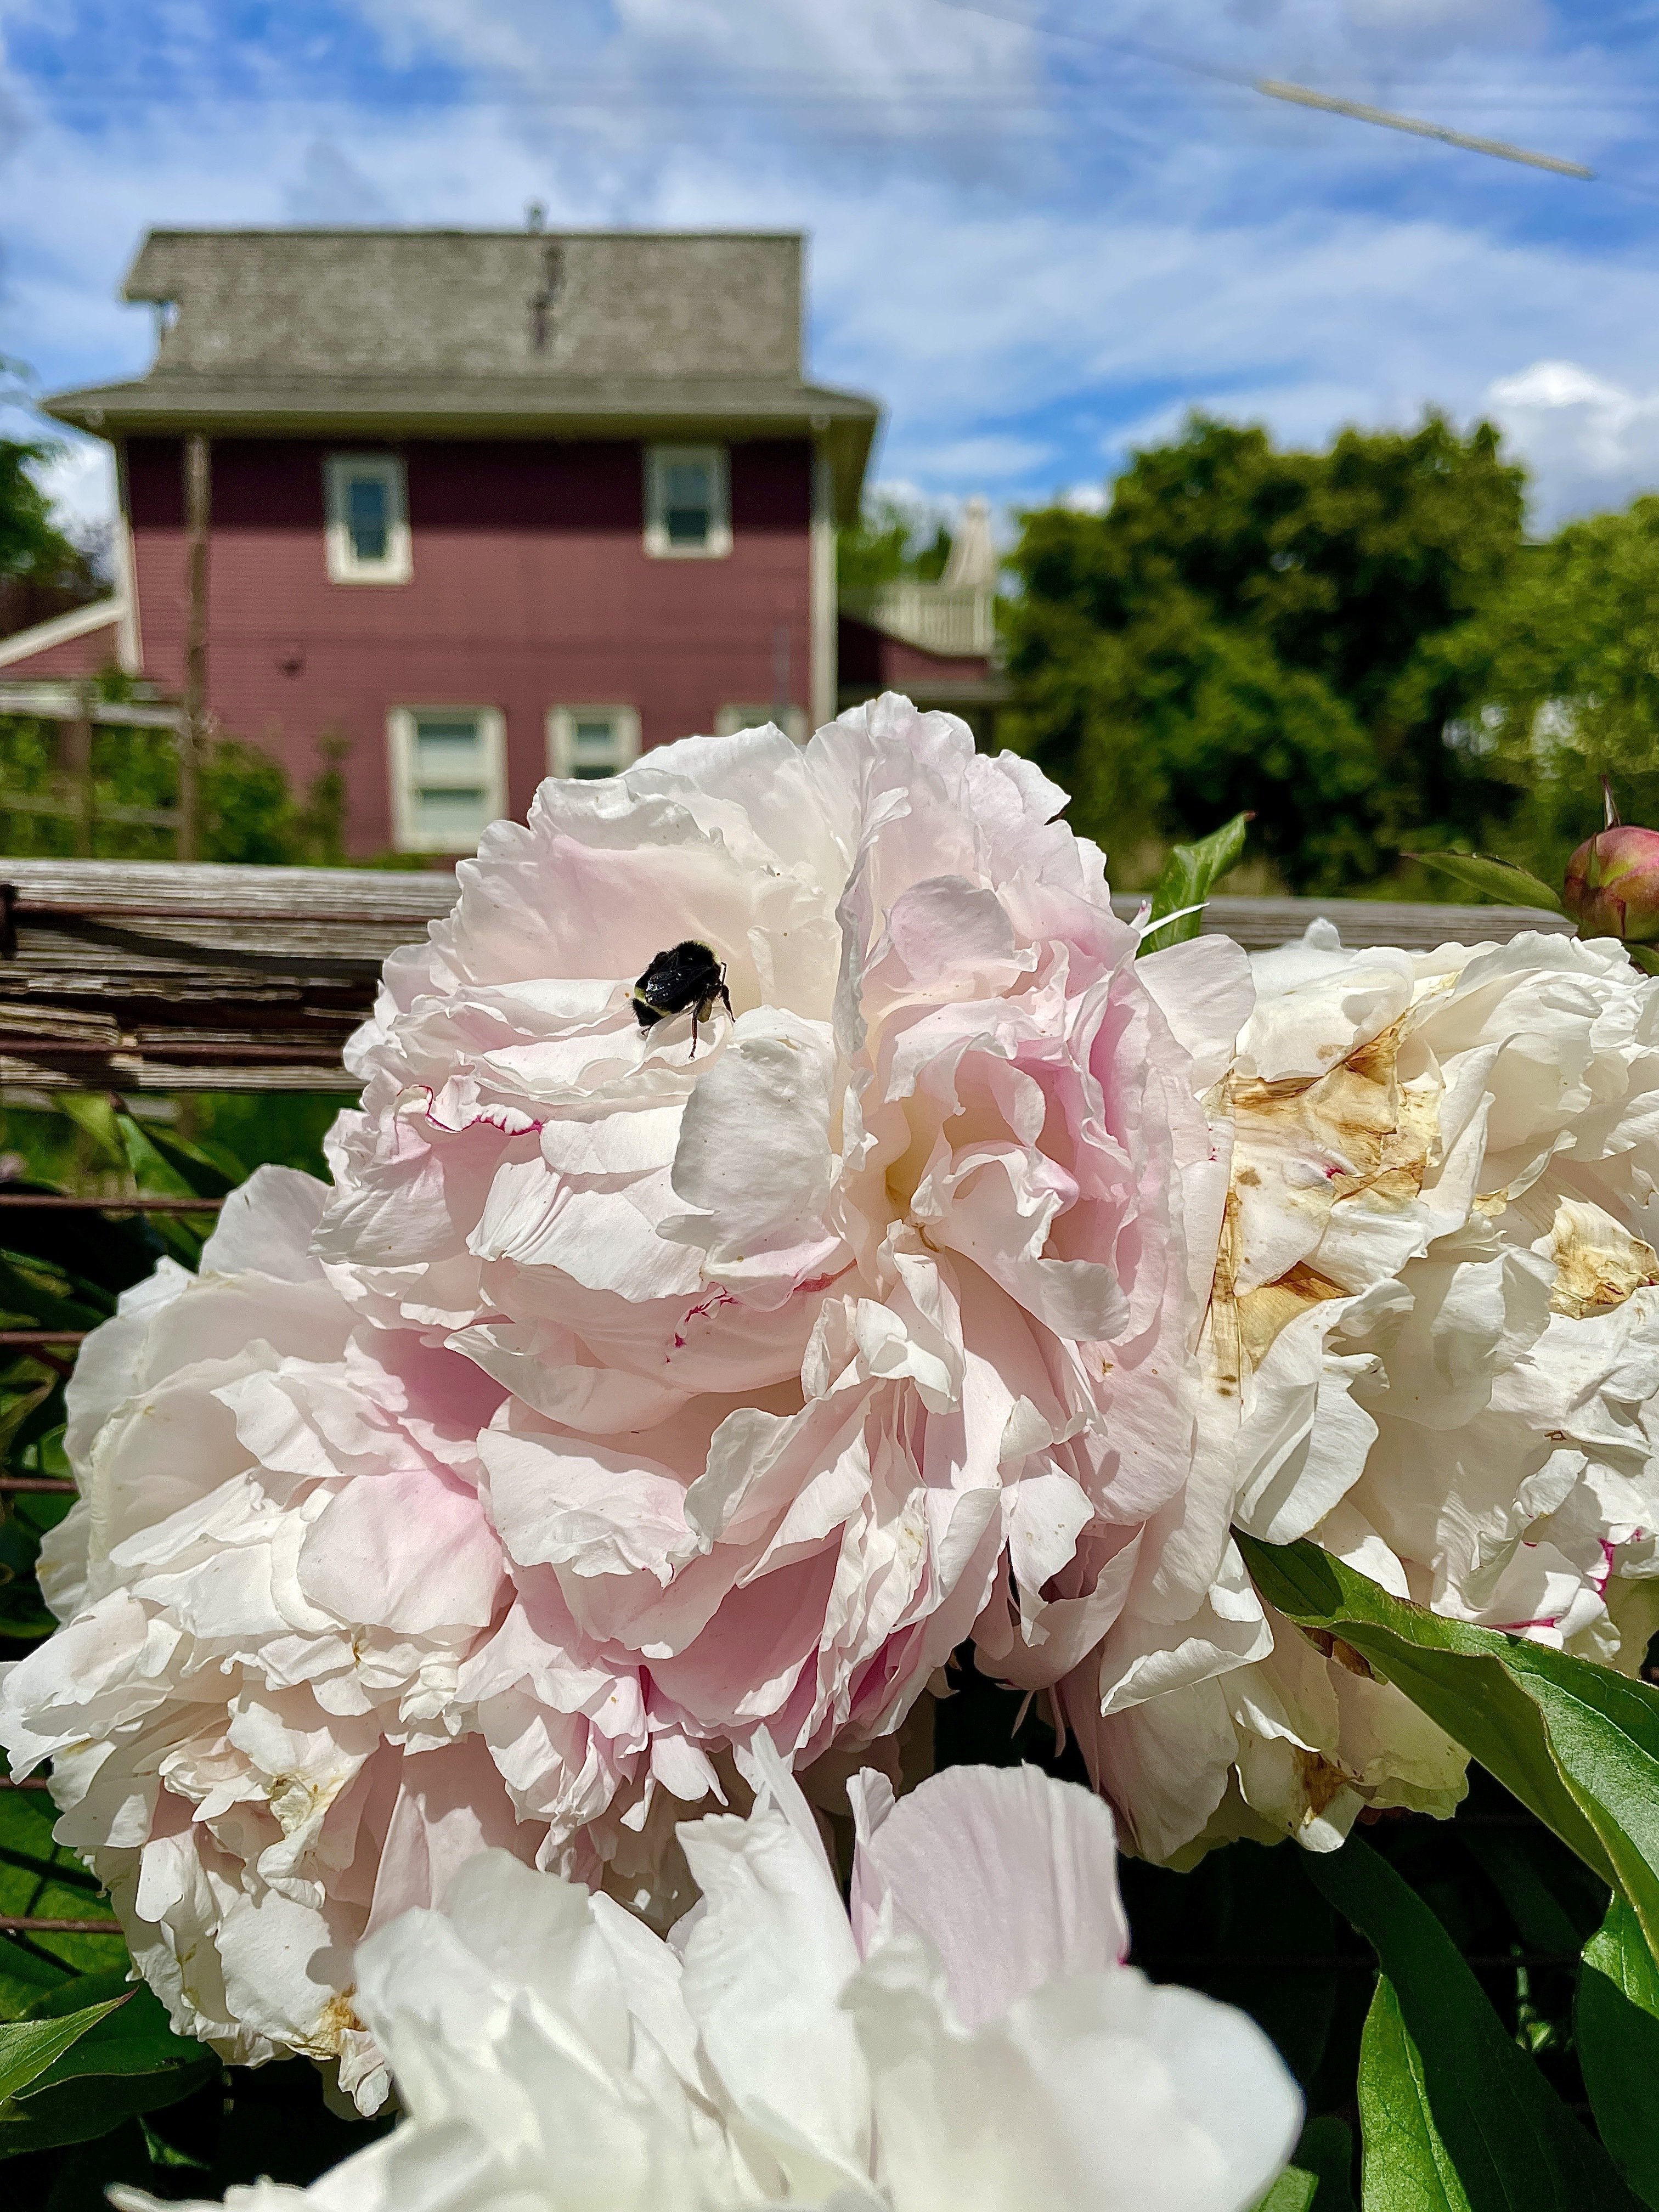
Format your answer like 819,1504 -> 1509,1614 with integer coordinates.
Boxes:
317,699 -> 1248,1876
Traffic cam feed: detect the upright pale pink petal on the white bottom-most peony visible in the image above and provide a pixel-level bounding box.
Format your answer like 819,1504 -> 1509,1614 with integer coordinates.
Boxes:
851,1768 -> 1128,2028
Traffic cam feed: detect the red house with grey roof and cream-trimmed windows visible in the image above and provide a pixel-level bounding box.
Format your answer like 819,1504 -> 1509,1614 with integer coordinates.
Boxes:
0,230 -> 884,854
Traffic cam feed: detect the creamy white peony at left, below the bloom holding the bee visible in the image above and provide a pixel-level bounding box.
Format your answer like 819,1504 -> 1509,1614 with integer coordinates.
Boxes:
0,1168 -> 528,2103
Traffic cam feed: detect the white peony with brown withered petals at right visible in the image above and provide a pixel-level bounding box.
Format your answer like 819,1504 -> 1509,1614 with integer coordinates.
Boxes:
1059,922 -> 1659,1858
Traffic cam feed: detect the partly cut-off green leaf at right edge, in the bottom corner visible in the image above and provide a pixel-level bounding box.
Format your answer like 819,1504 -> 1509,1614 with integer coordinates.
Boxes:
1573,1898 -> 1659,2205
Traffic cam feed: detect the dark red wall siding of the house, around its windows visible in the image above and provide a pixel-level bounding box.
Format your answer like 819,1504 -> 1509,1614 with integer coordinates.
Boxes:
126,438 -> 812,854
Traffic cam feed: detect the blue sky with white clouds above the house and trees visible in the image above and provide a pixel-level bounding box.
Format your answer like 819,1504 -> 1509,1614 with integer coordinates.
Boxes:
0,0 -> 1659,544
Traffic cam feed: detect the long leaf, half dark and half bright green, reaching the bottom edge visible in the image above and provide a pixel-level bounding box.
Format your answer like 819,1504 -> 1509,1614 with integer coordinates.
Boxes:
1307,1836 -> 1637,2212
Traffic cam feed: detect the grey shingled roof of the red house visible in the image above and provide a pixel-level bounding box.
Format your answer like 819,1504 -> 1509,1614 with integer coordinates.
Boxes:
47,230 -> 881,511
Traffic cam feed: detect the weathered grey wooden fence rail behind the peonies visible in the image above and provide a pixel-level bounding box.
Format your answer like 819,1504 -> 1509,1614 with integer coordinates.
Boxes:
0,858 -> 1571,1091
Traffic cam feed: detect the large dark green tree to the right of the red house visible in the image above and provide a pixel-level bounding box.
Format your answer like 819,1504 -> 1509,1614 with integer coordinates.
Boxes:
1009,414 -> 1522,889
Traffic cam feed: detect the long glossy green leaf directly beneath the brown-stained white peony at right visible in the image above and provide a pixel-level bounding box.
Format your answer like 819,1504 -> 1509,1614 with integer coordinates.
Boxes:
1239,1535 -> 1659,1949
